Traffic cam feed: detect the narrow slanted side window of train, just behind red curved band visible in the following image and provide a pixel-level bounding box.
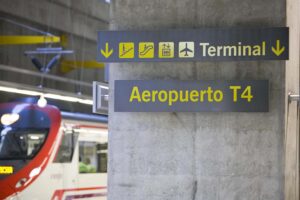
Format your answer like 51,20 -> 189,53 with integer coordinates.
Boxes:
54,130 -> 78,163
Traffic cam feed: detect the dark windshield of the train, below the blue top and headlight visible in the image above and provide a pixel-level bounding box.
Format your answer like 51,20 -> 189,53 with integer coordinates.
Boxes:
0,127 -> 48,160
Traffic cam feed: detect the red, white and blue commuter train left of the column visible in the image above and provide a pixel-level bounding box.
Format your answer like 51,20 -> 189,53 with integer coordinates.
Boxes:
0,102 -> 108,200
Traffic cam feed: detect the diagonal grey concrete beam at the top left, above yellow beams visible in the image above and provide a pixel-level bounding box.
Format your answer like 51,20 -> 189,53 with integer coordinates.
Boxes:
0,0 -> 108,41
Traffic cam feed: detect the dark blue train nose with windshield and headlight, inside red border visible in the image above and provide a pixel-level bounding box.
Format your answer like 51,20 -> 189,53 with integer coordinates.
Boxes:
0,104 -> 50,160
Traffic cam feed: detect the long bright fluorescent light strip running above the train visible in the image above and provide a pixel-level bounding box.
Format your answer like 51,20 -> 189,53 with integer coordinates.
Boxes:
0,86 -> 93,105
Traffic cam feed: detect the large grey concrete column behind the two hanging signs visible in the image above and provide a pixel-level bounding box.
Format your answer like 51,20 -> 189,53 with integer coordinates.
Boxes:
108,0 -> 285,200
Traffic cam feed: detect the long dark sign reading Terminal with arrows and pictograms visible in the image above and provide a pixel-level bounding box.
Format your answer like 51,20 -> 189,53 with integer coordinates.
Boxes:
98,27 -> 289,62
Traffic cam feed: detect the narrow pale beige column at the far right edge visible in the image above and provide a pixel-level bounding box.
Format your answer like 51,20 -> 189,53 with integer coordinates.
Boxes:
285,0 -> 300,200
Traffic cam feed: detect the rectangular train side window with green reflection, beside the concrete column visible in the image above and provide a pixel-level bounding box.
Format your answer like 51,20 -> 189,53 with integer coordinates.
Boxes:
79,141 -> 107,173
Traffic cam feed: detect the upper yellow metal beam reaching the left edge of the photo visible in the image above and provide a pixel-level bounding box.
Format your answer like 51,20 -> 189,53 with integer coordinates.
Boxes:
0,35 -> 60,45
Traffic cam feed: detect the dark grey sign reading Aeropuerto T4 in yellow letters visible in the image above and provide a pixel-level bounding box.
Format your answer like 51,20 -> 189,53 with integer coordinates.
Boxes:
114,80 -> 269,112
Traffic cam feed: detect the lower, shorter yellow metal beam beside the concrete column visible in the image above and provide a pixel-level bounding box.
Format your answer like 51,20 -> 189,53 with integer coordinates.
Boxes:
60,60 -> 105,73
